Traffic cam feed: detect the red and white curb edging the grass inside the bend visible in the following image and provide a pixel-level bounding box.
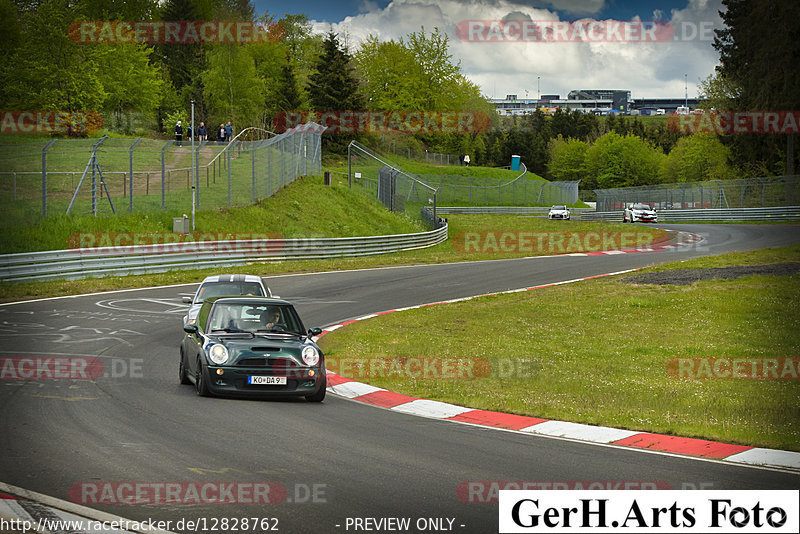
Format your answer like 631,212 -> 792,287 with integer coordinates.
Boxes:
320,268 -> 800,469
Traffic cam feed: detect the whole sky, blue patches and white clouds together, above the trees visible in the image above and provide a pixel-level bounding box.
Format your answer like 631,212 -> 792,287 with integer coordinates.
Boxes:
254,0 -> 722,99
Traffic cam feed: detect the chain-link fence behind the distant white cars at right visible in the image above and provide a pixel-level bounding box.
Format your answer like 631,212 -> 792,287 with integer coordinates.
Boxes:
595,175 -> 800,211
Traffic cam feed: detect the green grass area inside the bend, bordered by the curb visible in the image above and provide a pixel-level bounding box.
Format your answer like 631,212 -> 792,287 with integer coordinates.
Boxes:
321,246 -> 800,451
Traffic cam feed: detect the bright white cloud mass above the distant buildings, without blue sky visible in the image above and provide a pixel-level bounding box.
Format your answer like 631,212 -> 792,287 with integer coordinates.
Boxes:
315,0 -> 722,98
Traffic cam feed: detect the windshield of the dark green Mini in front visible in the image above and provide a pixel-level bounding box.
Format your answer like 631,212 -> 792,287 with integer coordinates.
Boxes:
208,302 -> 304,335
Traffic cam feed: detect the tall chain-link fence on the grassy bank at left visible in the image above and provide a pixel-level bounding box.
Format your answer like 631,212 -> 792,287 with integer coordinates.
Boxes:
0,123 -> 323,216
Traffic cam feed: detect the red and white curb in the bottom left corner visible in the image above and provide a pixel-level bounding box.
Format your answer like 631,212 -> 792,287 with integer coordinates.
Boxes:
0,482 -> 171,534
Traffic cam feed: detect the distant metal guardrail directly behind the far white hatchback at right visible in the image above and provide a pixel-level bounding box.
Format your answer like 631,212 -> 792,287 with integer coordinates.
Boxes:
581,206 -> 800,222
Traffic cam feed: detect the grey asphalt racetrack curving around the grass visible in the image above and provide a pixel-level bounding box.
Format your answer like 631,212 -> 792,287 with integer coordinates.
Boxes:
0,225 -> 800,533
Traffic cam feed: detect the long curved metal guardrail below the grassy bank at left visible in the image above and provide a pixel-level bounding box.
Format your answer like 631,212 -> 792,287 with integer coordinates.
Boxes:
0,225 -> 447,282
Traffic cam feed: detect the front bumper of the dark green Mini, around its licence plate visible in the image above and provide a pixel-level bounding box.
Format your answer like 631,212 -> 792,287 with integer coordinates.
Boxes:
207,366 -> 326,397
